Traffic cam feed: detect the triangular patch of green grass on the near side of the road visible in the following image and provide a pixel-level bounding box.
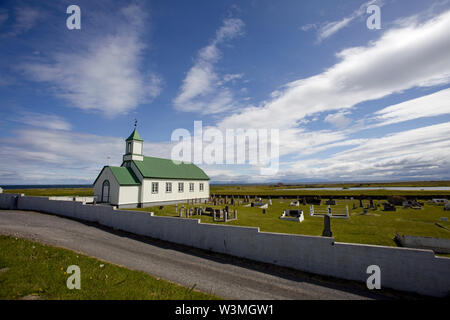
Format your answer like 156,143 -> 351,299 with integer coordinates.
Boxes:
0,235 -> 217,300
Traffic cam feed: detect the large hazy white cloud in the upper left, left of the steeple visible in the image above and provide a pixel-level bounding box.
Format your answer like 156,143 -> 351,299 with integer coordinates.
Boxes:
21,5 -> 161,116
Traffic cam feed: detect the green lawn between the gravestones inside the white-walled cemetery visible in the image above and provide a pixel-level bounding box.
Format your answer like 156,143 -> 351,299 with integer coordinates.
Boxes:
131,199 -> 450,251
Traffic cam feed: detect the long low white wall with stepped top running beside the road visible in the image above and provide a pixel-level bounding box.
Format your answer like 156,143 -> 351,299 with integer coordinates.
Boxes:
0,194 -> 450,297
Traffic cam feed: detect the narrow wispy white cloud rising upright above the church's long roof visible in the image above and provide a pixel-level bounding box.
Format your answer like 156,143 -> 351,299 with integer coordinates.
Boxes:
173,18 -> 244,114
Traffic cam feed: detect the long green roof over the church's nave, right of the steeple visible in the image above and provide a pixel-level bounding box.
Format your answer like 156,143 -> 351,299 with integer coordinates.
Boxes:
133,157 -> 209,180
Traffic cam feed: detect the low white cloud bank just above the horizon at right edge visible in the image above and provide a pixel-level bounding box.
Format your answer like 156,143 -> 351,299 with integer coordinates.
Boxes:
288,122 -> 450,180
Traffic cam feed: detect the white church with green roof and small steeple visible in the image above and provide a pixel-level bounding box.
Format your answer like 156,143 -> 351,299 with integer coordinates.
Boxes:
94,128 -> 209,208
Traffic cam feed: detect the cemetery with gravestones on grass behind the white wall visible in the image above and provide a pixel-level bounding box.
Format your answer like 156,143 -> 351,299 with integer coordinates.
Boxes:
130,195 -> 450,256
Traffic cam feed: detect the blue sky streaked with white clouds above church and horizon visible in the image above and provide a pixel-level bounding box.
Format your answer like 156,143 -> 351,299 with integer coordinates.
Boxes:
0,0 -> 450,185
